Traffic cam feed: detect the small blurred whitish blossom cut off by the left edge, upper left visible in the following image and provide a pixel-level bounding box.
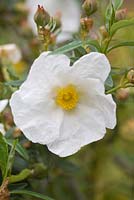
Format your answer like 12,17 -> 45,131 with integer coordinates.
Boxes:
0,44 -> 22,64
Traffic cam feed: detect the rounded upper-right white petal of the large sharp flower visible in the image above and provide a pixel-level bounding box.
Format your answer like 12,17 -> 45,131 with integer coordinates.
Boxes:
72,52 -> 110,82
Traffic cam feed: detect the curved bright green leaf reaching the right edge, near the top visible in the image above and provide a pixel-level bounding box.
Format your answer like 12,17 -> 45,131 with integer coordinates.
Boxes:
110,18 -> 134,36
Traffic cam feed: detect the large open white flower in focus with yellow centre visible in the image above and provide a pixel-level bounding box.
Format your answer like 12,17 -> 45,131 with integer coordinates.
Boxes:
10,52 -> 116,157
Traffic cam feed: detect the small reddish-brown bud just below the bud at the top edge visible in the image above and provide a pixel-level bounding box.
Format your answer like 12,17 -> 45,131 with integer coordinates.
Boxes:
80,17 -> 93,32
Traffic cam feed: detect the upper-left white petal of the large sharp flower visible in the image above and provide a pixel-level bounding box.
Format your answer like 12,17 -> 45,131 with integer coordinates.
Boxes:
21,52 -> 70,92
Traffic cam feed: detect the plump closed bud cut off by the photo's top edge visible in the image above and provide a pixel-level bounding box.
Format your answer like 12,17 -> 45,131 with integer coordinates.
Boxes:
82,0 -> 97,16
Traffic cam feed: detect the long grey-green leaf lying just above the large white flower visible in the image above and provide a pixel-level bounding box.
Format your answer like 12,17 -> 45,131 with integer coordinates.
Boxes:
52,40 -> 101,54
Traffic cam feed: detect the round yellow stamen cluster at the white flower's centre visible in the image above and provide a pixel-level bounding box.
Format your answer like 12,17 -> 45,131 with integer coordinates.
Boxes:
55,84 -> 79,110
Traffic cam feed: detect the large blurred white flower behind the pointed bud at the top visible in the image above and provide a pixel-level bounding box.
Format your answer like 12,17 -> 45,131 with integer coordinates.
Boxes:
26,0 -> 80,42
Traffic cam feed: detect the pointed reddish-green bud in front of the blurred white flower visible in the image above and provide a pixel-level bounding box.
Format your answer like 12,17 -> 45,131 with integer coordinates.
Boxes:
34,5 -> 50,27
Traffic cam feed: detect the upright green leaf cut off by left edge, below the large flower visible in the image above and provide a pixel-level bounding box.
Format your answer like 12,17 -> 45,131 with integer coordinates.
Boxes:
0,133 -> 8,177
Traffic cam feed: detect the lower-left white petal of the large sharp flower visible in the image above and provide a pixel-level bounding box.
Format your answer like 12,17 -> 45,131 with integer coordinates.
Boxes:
10,90 -> 63,144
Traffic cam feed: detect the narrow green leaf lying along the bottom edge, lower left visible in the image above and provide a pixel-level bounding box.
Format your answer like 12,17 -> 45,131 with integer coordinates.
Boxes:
10,190 -> 54,200
